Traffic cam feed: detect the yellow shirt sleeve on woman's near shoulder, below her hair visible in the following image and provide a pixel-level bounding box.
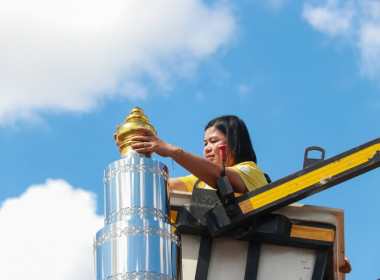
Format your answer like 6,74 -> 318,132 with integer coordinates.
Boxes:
231,161 -> 268,191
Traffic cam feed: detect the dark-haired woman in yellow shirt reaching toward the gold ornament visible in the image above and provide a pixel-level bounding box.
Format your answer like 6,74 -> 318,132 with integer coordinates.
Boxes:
130,115 -> 268,193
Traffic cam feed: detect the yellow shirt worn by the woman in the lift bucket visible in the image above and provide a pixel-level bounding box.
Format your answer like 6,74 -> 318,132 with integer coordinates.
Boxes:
179,161 -> 268,192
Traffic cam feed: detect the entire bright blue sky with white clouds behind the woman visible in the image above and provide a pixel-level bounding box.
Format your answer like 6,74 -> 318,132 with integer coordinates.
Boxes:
0,0 -> 380,280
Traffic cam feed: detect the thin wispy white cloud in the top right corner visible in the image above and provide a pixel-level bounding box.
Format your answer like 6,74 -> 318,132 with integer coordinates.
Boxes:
303,0 -> 380,79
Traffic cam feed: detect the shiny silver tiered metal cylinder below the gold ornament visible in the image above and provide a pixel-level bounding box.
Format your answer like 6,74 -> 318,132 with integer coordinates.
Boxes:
94,151 -> 180,280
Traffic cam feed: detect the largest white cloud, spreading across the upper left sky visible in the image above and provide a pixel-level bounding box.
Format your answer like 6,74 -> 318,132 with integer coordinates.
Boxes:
0,0 -> 236,125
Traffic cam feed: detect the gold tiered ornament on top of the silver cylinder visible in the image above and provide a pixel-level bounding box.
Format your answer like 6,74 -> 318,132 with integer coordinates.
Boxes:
115,107 -> 157,155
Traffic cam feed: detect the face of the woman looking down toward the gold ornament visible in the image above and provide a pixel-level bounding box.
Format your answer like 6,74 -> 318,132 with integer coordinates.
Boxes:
203,126 -> 234,166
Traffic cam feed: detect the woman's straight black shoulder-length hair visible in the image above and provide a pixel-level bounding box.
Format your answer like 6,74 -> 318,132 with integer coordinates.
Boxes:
205,115 -> 257,163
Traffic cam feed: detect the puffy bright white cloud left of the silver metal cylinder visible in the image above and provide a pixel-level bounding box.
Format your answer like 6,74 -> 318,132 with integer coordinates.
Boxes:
0,179 -> 103,280
